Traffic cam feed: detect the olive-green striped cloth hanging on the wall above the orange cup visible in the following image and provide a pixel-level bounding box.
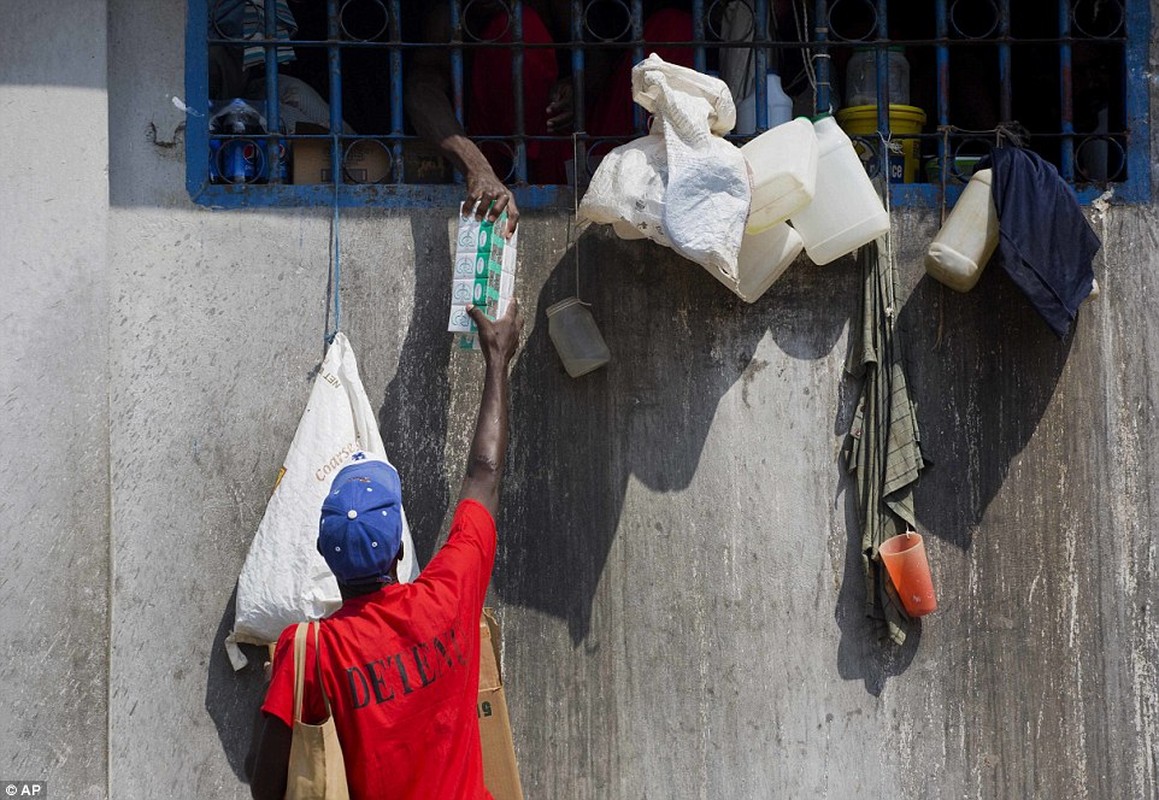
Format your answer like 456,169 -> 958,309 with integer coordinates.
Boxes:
846,239 -> 924,645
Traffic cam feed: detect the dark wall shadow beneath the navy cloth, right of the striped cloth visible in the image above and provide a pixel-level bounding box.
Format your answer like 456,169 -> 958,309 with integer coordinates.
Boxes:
898,263 -> 1083,550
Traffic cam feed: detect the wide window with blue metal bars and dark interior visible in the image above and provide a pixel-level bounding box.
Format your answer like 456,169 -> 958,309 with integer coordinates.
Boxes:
185,0 -> 1152,209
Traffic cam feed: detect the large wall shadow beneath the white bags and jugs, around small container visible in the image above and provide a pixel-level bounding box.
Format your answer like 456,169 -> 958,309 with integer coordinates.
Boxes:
494,231 -> 855,645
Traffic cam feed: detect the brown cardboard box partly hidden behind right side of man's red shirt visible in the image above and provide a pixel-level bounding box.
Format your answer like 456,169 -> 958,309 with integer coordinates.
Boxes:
478,609 -> 523,800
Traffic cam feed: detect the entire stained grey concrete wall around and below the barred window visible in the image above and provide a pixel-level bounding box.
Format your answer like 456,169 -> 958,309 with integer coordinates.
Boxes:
0,0 -> 1159,800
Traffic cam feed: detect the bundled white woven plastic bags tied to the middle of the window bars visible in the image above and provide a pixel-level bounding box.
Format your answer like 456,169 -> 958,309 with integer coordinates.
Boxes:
580,53 -> 751,284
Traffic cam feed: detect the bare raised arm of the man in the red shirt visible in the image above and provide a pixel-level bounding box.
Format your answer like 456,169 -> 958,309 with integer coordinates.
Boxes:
459,299 -> 523,518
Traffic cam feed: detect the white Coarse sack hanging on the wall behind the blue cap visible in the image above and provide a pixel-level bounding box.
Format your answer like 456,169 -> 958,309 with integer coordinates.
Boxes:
226,333 -> 418,669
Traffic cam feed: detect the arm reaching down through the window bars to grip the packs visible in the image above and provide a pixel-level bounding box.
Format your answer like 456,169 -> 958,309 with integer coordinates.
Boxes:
404,2 -> 519,237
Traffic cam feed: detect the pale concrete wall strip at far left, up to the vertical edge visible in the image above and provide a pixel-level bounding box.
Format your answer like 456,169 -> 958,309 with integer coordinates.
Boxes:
0,0 -> 109,798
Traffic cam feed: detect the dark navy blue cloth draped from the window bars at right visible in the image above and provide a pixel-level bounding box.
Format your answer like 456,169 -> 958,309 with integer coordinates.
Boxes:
977,147 -> 1101,339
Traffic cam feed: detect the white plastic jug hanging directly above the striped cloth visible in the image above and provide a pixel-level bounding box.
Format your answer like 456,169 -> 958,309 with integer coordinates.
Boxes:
789,116 -> 889,264
